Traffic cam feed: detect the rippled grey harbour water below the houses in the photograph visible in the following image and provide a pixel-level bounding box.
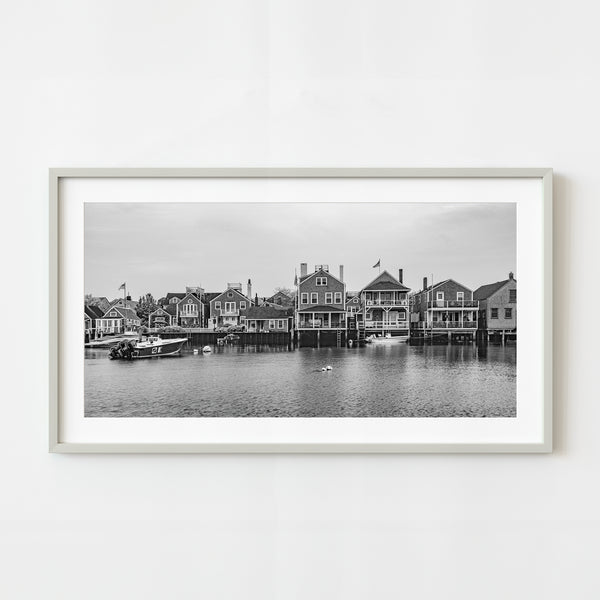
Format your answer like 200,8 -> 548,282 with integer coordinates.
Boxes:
85,344 -> 516,417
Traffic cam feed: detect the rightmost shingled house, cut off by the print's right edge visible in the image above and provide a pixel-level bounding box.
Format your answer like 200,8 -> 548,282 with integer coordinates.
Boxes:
473,273 -> 517,341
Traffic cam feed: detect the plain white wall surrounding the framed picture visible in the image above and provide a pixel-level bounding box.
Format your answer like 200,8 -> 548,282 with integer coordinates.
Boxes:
0,0 -> 600,600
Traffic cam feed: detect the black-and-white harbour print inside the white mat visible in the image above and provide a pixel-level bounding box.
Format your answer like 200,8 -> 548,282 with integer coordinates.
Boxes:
82,197 -> 518,419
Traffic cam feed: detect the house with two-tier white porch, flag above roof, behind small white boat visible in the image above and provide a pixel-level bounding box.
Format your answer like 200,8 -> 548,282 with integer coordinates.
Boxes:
359,269 -> 410,335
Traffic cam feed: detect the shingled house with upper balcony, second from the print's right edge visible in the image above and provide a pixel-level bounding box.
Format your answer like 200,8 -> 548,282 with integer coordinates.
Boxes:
410,277 -> 478,339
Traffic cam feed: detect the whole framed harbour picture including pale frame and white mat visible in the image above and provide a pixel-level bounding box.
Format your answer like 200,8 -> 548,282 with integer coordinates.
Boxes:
50,169 -> 552,453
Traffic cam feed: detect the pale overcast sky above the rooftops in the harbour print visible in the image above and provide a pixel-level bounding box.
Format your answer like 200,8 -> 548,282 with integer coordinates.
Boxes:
85,202 -> 518,299
